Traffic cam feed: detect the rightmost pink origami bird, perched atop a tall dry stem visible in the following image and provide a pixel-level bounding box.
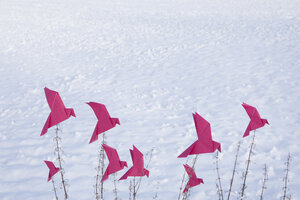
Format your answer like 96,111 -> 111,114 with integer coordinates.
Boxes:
242,103 -> 269,137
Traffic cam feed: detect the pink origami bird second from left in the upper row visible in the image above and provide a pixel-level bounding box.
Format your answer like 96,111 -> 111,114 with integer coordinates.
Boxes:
87,102 -> 120,144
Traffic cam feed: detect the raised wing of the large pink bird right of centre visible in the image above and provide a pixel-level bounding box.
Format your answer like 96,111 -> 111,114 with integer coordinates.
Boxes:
193,113 -> 212,142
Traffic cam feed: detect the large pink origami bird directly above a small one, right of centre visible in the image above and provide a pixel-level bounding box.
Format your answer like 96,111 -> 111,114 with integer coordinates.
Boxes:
178,113 -> 221,158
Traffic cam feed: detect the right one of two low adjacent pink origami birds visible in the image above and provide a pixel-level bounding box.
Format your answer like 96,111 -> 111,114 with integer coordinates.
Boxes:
119,145 -> 149,180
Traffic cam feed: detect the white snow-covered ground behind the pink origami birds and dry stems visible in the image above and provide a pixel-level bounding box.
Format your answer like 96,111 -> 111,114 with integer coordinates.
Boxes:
0,0 -> 300,200
